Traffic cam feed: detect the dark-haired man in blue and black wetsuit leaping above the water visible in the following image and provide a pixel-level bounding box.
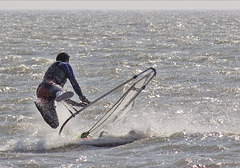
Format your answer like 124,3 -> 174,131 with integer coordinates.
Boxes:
35,52 -> 90,128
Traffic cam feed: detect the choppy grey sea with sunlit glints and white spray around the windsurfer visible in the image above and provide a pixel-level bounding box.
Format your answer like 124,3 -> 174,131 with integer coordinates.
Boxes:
0,11 -> 240,167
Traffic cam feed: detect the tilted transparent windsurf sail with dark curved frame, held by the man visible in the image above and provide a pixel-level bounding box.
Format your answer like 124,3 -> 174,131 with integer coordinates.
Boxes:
59,67 -> 156,138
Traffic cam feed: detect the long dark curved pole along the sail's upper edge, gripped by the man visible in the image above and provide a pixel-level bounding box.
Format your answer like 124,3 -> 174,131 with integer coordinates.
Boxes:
59,67 -> 156,135
